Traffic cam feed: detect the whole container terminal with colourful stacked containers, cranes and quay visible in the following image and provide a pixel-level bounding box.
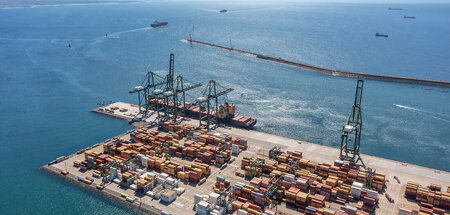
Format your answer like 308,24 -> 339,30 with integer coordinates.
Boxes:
41,55 -> 450,215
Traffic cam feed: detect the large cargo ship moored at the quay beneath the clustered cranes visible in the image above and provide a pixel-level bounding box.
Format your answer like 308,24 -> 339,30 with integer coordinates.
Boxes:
149,99 -> 257,129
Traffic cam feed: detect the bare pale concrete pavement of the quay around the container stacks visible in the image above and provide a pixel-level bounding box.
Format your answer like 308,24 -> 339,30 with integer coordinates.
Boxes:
41,102 -> 450,214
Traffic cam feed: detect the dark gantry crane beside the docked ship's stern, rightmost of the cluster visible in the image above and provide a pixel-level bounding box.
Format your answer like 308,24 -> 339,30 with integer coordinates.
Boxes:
191,80 -> 234,131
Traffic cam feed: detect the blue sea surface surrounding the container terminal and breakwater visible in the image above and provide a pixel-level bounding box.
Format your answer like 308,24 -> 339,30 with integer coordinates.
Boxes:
0,1 -> 450,214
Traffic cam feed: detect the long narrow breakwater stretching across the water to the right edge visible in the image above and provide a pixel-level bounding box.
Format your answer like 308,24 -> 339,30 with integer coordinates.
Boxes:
181,39 -> 450,88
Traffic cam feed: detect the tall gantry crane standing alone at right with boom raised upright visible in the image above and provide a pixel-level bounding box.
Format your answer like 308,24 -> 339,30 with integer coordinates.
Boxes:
339,80 -> 364,165
